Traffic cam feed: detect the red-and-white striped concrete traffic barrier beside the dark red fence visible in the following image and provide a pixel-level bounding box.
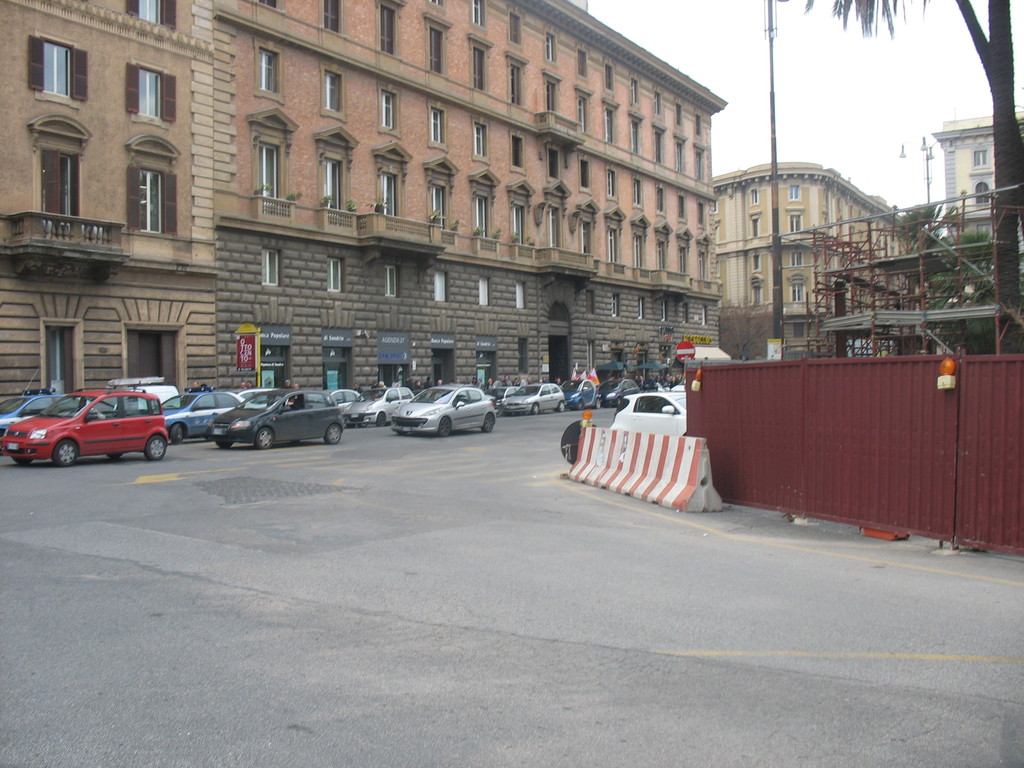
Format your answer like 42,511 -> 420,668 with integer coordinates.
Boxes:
568,427 -> 722,512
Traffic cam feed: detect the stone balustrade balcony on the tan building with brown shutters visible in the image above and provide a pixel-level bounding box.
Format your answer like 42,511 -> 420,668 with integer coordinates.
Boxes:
0,211 -> 130,282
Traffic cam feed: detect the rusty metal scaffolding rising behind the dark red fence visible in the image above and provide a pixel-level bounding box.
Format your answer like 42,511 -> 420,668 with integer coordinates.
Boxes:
802,190 -> 1024,357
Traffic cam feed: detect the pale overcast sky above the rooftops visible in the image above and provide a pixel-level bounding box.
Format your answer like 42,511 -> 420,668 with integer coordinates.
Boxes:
589,0 -> 1024,208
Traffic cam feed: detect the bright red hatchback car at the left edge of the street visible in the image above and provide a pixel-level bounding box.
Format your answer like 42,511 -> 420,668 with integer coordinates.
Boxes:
3,390 -> 167,467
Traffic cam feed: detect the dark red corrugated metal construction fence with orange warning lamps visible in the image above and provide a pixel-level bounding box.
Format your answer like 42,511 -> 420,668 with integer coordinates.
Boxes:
687,355 -> 1024,554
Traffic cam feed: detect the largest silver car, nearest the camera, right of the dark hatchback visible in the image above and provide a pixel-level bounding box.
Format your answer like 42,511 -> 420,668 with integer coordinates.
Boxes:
391,384 -> 495,437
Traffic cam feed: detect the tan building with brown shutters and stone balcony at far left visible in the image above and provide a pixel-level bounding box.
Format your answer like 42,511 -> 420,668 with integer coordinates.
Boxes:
0,0 -> 215,392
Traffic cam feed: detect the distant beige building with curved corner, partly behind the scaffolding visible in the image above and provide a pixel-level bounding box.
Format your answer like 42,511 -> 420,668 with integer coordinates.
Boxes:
715,163 -> 890,356
